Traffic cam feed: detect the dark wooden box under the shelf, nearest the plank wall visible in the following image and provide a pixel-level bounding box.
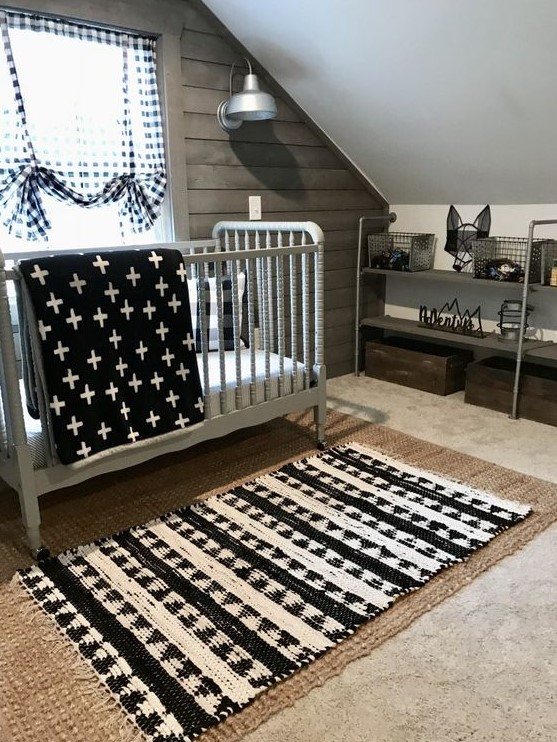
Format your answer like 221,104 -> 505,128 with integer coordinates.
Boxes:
366,337 -> 473,396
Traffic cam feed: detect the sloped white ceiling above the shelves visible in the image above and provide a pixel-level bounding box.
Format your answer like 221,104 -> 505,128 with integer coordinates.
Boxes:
204,0 -> 557,204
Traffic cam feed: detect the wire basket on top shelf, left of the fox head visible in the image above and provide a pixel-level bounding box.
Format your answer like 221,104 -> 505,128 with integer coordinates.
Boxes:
367,232 -> 435,271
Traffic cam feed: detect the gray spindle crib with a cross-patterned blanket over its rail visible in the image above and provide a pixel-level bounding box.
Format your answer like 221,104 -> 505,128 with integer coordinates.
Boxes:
0,222 -> 326,558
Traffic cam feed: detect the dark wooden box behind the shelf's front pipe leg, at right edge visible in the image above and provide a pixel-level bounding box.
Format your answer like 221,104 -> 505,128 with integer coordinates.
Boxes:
464,356 -> 557,425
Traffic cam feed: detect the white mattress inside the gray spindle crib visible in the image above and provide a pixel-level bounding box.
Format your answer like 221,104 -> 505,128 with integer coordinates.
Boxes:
6,349 -> 304,469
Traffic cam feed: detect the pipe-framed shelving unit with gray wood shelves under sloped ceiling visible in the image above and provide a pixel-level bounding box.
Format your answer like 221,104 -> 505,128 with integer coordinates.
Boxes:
354,214 -> 557,419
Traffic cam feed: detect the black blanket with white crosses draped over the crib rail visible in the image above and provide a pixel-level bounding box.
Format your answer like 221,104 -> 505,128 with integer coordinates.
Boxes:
18,253 -> 203,464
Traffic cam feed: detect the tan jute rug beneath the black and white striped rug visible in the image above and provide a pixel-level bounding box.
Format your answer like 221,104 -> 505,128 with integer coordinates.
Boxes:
0,413 -> 556,741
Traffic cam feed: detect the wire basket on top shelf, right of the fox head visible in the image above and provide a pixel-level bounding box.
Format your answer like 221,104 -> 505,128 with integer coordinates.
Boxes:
471,237 -> 542,283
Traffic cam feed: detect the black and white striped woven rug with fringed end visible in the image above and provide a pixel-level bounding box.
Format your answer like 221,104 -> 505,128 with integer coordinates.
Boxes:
18,444 -> 529,742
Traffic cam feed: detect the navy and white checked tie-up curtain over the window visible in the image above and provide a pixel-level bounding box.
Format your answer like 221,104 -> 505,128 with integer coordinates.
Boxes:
0,11 -> 166,241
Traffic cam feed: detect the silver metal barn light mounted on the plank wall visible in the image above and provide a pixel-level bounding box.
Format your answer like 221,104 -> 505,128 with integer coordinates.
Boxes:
217,57 -> 277,131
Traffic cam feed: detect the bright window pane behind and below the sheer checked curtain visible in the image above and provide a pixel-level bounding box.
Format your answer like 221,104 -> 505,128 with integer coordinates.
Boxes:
0,14 -> 165,250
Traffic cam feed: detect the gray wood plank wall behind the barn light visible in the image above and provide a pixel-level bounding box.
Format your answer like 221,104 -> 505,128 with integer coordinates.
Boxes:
181,0 -> 387,377
